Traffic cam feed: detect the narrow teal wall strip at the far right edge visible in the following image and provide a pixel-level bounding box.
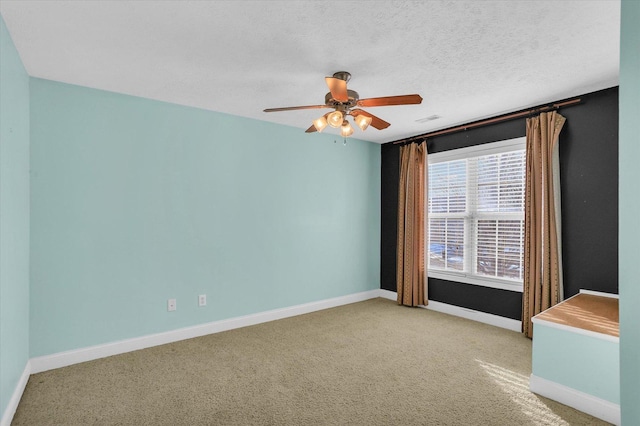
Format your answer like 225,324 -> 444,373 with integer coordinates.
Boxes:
618,0 -> 640,425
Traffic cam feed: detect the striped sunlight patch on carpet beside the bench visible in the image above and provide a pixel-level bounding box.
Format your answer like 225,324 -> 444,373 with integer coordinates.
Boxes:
476,359 -> 569,426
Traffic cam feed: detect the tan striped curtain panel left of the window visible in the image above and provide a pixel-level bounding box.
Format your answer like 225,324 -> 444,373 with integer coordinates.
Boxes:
396,142 -> 427,306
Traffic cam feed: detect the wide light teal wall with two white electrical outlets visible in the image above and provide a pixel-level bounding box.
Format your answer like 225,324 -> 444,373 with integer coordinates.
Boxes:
31,79 -> 380,356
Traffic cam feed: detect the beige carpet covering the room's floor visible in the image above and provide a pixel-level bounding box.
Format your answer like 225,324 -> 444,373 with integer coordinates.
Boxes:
12,299 -> 606,426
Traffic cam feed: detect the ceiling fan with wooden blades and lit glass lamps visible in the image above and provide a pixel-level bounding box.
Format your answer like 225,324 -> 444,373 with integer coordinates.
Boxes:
264,71 -> 422,138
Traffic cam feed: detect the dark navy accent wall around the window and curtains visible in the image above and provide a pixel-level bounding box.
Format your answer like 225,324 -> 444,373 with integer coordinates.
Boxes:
380,87 -> 618,320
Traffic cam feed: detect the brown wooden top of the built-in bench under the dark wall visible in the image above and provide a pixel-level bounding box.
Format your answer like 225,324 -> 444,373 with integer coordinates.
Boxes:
535,293 -> 620,337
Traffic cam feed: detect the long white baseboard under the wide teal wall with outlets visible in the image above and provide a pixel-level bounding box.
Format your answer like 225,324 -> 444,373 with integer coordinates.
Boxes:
31,290 -> 379,374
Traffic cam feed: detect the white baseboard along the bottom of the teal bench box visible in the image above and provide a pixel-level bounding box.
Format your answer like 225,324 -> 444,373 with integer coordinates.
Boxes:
529,374 -> 621,425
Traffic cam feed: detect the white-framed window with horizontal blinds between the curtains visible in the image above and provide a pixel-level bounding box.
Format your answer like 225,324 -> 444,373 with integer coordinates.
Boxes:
427,138 -> 525,291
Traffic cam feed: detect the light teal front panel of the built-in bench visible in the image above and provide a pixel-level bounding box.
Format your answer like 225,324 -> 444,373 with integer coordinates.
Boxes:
531,323 -> 620,404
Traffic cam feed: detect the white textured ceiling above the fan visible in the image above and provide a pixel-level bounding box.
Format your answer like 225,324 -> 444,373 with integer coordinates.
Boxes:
0,0 -> 620,143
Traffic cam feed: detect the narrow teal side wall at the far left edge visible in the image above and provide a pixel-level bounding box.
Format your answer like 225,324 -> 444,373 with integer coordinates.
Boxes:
0,17 -> 29,417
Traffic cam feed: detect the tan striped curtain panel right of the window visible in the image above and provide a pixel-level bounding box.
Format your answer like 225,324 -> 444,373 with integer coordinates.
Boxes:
522,111 -> 566,338
